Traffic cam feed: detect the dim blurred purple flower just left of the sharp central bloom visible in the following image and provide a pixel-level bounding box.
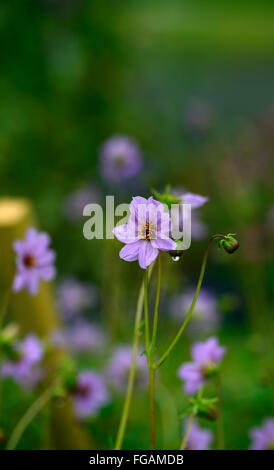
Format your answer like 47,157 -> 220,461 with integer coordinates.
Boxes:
64,185 -> 101,222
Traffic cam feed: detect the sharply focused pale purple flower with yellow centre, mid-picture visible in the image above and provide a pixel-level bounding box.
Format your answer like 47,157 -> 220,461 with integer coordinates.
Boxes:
113,196 -> 176,269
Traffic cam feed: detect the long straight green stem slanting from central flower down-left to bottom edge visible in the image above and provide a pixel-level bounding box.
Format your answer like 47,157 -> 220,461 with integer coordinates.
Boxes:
114,265 -> 153,450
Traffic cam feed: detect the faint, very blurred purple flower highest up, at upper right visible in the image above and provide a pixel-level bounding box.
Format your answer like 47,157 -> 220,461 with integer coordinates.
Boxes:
184,100 -> 212,135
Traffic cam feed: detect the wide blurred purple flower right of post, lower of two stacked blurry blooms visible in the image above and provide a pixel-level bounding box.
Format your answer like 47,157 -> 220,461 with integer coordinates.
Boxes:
52,320 -> 107,353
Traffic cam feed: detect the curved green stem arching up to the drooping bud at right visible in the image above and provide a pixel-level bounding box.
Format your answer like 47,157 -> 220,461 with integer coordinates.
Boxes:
155,235 -> 225,369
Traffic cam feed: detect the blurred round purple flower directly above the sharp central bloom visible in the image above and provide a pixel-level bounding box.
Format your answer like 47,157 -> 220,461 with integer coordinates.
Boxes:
100,135 -> 143,183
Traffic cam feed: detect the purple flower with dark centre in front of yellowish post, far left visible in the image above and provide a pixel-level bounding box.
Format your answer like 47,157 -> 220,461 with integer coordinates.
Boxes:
13,227 -> 56,295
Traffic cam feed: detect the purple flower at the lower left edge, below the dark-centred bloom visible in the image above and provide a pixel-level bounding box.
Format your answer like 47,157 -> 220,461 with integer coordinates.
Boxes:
1,334 -> 44,388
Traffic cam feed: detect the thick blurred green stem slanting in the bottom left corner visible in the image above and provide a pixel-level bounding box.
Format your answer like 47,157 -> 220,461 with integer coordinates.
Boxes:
6,386 -> 53,450
